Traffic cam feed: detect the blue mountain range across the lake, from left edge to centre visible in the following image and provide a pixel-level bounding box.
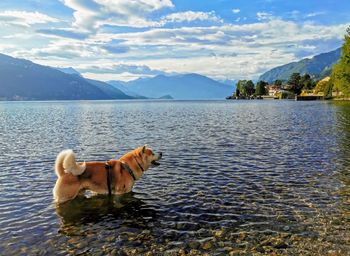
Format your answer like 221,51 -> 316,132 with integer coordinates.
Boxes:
0,54 -> 233,100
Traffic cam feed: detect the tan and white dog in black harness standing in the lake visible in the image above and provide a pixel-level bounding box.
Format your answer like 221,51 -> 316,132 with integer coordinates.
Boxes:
53,145 -> 162,203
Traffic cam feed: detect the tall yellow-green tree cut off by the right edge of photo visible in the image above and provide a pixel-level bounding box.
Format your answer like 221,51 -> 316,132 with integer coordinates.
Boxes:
331,26 -> 350,97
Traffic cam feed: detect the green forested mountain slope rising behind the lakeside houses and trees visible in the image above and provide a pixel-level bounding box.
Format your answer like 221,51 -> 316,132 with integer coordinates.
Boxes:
259,48 -> 341,83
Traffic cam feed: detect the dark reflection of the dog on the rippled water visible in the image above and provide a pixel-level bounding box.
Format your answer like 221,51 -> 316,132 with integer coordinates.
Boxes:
56,192 -> 157,235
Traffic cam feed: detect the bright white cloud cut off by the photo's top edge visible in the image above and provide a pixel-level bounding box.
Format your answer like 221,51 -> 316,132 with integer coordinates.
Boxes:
64,0 -> 223,31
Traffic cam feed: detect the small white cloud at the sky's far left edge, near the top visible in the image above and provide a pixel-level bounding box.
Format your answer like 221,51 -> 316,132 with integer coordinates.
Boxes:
0,11 -> 59,27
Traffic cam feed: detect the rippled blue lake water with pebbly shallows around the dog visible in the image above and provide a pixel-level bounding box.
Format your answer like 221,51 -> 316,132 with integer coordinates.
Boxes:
0,100 -> 350,255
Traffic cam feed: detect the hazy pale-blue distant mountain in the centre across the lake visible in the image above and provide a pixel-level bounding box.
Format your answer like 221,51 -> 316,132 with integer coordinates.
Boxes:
121,74 -> 233,100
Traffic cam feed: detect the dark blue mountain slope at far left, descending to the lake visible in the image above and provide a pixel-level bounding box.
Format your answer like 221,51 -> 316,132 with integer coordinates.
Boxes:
0,54 -> 128,100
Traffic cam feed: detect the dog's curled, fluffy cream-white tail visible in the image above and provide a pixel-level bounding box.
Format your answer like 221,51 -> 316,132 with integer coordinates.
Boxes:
55,149 -> 86,177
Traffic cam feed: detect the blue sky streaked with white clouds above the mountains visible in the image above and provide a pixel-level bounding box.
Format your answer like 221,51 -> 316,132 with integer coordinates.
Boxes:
0,0 -> 350,81
